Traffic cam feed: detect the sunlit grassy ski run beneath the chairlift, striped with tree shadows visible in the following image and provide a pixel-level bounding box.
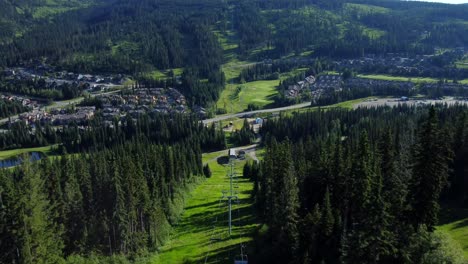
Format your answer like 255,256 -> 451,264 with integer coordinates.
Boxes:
151,150 -> 259,264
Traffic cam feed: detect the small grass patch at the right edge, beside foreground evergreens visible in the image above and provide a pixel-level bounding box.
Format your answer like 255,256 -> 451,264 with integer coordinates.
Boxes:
437,208 -> 468,262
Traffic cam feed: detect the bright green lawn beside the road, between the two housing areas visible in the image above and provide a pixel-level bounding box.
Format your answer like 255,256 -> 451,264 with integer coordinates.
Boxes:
217,80 -> 279,113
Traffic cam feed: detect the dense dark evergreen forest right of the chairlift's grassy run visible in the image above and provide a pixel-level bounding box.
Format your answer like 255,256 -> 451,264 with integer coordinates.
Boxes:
249,106 -> 468,263
